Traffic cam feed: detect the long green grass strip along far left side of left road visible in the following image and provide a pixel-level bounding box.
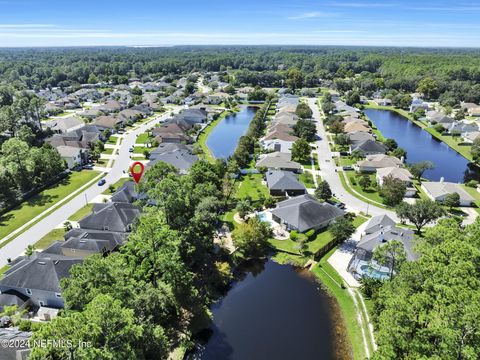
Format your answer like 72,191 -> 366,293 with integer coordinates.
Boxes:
0,170 -> 100,247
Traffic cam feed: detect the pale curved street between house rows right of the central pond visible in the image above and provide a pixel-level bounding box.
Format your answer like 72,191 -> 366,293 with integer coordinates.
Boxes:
308,98 -> 400,222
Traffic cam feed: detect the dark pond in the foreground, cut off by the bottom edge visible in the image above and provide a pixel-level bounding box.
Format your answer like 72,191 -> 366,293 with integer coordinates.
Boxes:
189,260 -> 349,360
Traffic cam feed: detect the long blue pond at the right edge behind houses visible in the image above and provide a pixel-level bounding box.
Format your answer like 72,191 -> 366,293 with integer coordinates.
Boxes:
365,109 -> 480,183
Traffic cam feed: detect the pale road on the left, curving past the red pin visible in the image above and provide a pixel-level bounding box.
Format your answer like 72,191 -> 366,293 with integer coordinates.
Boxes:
0,107 -> 180,267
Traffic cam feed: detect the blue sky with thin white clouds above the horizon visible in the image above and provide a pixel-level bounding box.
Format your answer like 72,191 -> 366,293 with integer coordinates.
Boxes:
0,0 -> 480,47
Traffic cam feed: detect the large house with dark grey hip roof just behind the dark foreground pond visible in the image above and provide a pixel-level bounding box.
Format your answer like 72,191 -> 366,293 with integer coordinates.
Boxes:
271,195 -> 346,232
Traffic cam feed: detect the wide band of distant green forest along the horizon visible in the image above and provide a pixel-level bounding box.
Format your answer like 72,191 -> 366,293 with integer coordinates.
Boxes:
0,46 -> 480,106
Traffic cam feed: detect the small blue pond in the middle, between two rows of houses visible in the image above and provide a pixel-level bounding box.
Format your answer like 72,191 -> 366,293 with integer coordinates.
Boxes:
207,106 -> 258,159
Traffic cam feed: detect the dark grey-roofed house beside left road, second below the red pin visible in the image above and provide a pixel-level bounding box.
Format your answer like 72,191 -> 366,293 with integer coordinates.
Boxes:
78,203 -> 140,232
